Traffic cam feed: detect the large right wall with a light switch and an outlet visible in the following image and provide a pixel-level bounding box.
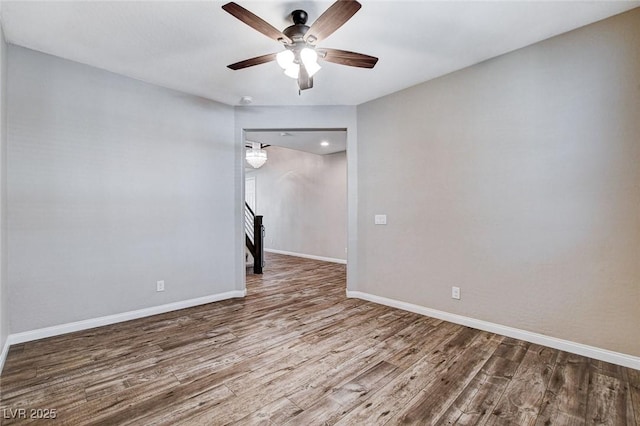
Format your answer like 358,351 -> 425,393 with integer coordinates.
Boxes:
354,9 -> 640,356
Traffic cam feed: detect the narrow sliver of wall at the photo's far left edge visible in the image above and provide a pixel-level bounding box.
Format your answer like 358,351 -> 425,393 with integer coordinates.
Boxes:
0,19 -> 9,360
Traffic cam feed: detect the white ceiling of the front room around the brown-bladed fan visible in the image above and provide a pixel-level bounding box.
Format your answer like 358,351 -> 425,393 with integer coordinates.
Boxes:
2,0 -> 640,105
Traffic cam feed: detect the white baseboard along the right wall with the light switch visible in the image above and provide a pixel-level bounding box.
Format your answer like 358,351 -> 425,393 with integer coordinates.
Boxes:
347,290 -> 640,370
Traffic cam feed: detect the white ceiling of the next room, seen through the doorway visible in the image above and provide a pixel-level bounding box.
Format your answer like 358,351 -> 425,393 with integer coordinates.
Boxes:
245,129 -> 347,155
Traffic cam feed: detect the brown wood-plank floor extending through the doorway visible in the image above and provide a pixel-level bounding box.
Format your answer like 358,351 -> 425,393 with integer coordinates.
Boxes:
0,255 -> 640,425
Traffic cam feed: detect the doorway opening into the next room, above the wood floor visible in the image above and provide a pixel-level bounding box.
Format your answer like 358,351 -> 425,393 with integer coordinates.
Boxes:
244,129 -> 348,274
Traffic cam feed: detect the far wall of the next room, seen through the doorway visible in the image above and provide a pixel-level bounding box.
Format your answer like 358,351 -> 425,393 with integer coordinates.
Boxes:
247,146 -> 347,260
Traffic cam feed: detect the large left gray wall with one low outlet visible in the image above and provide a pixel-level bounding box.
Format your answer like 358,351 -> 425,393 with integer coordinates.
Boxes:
7,46 -> 237,333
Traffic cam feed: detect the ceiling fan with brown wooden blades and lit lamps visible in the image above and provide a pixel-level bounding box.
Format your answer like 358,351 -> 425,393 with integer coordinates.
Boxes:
222,0 -> 378,90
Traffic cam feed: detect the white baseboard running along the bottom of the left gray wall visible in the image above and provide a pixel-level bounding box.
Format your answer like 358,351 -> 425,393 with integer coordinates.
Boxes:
0,290 -> 246,352
